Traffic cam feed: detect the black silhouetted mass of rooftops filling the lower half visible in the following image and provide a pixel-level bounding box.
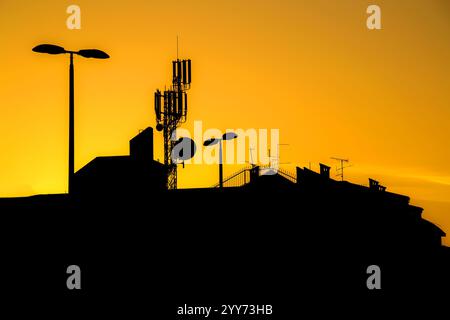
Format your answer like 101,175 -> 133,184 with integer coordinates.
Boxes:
0,128 -> 450,308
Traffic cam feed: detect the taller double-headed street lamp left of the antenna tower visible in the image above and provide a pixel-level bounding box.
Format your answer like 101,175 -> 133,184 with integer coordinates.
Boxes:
33,44 -> 109,194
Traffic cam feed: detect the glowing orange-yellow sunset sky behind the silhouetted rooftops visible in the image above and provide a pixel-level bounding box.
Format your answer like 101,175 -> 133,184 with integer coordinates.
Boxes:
0,0 -> 450,244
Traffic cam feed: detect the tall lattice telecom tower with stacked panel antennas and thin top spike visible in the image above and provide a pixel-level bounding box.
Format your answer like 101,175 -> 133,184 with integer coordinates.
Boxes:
155,42 -> 192,190
